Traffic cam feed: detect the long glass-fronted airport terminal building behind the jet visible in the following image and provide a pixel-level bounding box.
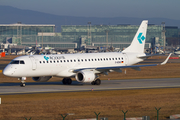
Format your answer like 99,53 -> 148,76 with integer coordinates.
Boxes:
0,23 -> 179,49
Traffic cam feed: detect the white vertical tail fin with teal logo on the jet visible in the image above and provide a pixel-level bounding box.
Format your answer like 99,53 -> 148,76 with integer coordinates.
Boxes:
122,20 -> 148,53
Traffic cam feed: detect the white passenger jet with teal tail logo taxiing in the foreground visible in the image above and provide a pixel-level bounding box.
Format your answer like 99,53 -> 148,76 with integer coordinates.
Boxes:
3,20 -> 171,87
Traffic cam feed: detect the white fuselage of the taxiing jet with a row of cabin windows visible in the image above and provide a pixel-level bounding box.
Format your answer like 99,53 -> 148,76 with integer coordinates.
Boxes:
3,52 -> 145,77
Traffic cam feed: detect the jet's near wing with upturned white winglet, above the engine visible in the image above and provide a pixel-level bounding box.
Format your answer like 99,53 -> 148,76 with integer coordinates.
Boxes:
73,53 -> 172,73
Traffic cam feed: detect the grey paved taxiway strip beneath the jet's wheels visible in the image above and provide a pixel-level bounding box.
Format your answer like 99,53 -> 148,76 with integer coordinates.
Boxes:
0,78 -> 180,95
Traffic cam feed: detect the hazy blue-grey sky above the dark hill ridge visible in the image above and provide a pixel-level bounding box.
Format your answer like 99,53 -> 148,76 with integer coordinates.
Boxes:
0,0 -> 180,20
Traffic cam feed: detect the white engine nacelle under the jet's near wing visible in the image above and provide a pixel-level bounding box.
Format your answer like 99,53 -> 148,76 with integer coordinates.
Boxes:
75,70 -> 96,82
